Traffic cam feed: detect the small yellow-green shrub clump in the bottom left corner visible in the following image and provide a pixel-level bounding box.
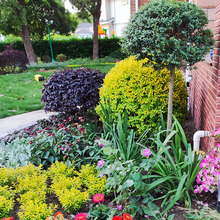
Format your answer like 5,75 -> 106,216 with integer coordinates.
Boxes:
0,195 -> 14,219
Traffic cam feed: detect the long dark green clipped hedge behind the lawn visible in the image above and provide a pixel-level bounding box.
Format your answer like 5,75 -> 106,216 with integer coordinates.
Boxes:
0,38 -> 120,59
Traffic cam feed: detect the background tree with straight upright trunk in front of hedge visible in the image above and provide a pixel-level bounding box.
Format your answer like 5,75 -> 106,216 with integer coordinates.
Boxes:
70,0 -> 102,59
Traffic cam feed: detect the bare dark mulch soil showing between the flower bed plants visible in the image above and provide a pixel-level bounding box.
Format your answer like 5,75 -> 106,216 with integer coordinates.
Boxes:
2,112 -> 217,220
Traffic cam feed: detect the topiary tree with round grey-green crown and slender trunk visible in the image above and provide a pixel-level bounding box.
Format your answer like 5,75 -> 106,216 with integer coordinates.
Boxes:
121,0 -> 214,132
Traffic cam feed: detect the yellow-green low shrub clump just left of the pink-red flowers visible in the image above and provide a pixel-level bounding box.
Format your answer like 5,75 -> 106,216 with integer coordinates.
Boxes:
49,162 -> 106,212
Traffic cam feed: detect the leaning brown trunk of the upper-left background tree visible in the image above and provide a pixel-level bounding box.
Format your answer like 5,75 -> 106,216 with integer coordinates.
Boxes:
21,25 -> 37,63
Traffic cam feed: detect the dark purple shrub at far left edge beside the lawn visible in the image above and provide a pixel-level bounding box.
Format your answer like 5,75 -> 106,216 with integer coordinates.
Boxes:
0,45 -> 29,75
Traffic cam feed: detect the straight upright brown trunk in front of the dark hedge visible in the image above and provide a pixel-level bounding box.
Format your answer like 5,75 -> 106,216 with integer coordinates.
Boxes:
93,0 -> 102,60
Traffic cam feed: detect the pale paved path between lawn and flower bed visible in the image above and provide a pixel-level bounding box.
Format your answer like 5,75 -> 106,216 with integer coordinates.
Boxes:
0,110 -> 56,138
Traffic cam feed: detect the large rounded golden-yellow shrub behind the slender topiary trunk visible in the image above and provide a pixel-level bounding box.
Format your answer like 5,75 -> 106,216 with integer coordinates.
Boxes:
96,57 -> 187,133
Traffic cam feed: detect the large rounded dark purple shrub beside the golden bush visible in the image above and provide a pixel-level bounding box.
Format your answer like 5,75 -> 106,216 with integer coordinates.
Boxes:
42,68 -> 104,114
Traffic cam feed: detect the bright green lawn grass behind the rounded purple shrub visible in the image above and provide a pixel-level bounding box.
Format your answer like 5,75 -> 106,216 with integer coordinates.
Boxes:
0,63 -> 115,118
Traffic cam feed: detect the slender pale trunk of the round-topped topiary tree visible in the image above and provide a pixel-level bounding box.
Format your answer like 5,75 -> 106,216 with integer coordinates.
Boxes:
167,66 -> 175,136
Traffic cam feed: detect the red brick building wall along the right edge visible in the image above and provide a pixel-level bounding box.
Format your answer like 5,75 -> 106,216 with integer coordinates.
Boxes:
190,0 -> 220,150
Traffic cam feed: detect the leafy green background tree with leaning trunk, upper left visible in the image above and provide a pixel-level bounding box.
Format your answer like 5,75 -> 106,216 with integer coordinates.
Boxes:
0,0 -> 78,62
